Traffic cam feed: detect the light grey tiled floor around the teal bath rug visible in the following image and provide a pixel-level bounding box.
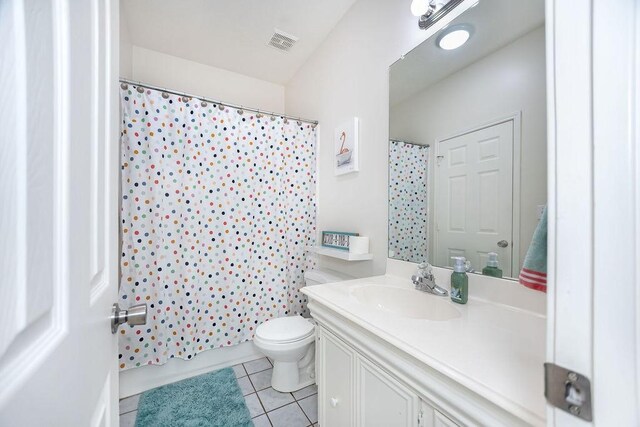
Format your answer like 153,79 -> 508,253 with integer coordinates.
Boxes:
120,357 -> 318,427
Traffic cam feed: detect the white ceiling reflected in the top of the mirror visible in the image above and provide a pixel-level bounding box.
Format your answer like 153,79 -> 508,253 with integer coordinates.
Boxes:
389,0 -> 544,105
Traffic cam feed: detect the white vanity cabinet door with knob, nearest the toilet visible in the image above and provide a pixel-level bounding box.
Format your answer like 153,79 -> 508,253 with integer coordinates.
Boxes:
318,329 -> 356,427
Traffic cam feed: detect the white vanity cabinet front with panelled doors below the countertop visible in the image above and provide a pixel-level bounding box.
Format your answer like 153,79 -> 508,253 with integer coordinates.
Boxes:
316,325 -> 458,427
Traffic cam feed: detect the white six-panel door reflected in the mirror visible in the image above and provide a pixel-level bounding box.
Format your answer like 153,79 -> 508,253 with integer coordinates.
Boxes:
435,120 -> 514,277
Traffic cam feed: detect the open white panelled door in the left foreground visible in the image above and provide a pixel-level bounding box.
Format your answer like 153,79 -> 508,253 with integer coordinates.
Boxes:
0,0 -> 118,426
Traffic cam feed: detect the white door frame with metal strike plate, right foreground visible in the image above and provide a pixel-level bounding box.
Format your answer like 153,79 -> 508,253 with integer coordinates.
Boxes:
546,0 -> 640,427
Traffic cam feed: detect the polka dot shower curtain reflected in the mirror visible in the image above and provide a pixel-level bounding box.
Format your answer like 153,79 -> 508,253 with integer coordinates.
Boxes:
389,141 -> 429,262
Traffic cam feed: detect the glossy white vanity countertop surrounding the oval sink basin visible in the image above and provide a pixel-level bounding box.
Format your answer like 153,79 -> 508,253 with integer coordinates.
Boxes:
302,275 -> 546,425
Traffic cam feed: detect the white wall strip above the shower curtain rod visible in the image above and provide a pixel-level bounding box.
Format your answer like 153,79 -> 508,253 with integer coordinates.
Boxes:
132,46 -> 284,113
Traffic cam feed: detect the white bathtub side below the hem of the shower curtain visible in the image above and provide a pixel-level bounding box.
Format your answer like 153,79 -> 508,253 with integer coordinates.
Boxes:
120,341 -> 262,399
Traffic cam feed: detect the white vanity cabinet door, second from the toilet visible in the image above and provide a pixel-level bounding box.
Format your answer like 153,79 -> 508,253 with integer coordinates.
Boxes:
357,358 -> 420,427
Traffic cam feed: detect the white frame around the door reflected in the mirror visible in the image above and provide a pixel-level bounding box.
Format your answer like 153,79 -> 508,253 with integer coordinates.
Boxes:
432,111 -> 522,279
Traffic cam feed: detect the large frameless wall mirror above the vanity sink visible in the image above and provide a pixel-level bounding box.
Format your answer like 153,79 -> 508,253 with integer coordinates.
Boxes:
389,0 -> 547,278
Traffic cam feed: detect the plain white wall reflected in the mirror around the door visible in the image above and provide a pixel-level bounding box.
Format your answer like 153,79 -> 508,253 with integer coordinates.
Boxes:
389,26 -> 547,274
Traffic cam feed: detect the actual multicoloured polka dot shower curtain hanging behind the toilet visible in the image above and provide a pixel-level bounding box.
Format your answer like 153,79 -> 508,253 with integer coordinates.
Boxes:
120,85 -> 316,369
